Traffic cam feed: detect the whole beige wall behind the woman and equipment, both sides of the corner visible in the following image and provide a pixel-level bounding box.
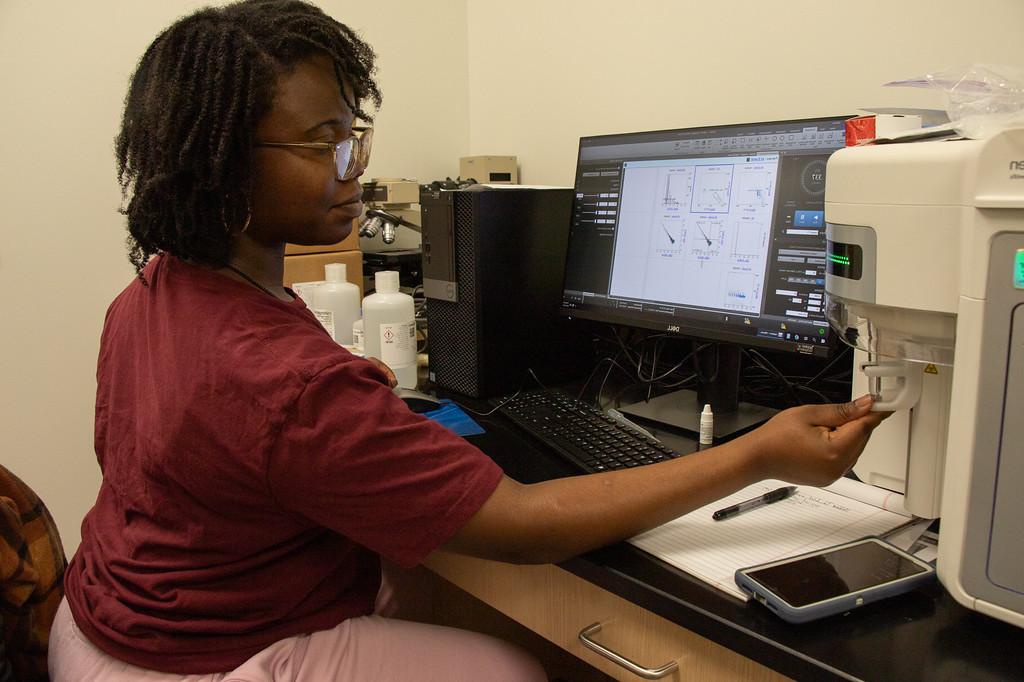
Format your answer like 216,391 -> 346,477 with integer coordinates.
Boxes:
0,0 -> 1024,551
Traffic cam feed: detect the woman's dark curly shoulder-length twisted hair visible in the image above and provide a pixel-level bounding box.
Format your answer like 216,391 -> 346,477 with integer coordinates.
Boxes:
116,0 -> 381,276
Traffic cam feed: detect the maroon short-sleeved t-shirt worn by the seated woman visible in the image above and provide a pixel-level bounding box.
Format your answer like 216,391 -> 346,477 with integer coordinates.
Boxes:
66,255 -> 501,674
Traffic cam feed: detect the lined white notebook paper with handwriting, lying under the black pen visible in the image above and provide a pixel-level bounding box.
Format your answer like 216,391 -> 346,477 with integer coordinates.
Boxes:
629,478 -> 913,601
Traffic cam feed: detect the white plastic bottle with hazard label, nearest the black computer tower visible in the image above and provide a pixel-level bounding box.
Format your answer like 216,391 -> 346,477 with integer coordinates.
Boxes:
362,270 -> 416,388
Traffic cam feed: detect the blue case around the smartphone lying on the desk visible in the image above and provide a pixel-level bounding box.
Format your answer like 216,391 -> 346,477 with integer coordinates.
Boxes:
735,537 -> 935,623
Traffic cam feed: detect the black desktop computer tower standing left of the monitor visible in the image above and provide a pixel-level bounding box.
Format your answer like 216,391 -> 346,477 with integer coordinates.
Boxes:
420,187 -> 591,397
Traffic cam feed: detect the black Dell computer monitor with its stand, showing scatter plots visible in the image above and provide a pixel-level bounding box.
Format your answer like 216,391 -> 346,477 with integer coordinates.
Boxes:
561,116 -> 849,435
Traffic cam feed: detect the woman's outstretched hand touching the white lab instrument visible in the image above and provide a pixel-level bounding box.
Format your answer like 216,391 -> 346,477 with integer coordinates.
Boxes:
741,395 -> 891,485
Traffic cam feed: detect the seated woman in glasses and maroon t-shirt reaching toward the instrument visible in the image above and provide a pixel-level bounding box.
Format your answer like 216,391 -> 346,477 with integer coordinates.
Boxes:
50,0 -> 880,682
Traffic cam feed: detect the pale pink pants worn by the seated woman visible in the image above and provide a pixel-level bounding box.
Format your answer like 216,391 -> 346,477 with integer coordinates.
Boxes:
49,601 -> 548,682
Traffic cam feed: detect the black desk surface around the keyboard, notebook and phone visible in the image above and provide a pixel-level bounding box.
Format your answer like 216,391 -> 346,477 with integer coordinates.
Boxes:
460,404 -> 1024,681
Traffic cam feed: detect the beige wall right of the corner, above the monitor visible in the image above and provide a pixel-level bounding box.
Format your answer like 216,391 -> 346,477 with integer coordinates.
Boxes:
469,0 -> 1024,185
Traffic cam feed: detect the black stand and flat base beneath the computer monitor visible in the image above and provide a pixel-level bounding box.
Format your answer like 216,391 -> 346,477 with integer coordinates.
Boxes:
618,343 -> 778,441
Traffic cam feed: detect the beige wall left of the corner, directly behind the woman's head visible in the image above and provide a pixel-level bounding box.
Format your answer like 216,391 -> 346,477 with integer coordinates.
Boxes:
0,0 -> 469,553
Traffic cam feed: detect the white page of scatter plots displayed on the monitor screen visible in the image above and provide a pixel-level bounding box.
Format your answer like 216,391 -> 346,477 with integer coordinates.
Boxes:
609,154 -> 779,314
